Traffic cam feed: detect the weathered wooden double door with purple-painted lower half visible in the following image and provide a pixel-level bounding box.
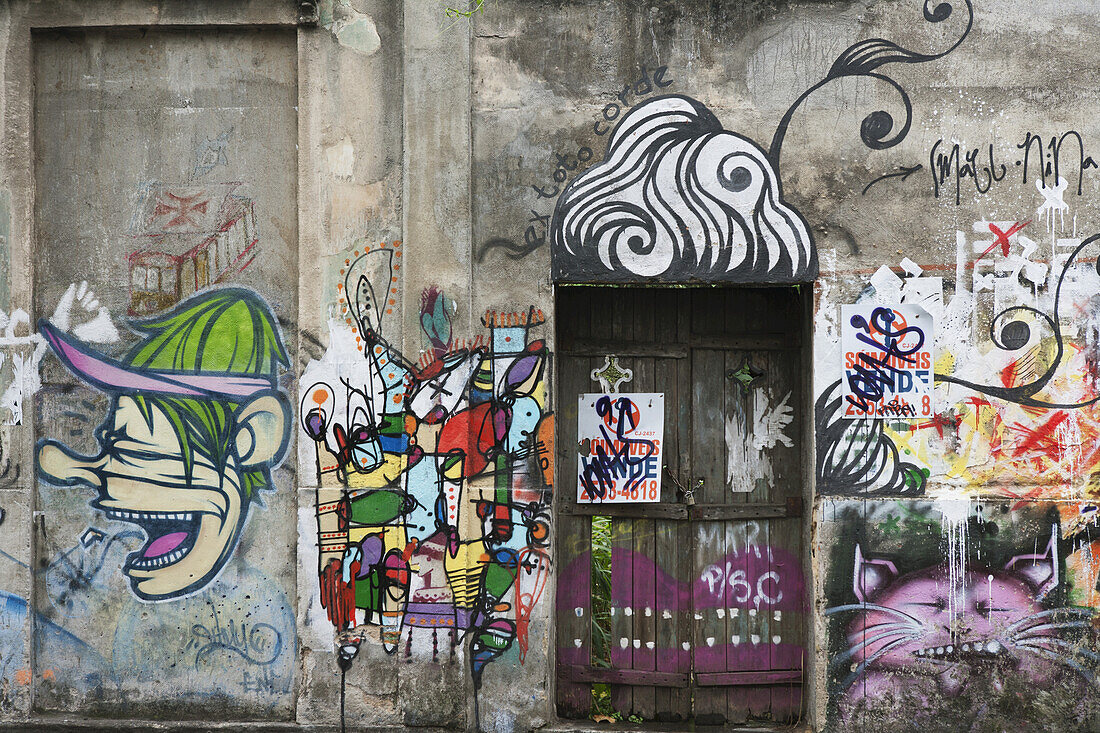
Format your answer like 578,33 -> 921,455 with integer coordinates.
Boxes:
556,286 -> 810,725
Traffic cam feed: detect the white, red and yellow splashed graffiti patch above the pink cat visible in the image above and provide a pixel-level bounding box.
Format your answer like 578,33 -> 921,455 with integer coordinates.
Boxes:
816,214 -> 1100,499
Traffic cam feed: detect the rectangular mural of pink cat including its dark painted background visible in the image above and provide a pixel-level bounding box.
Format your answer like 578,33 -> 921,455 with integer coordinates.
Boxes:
823,500 -> 1100,730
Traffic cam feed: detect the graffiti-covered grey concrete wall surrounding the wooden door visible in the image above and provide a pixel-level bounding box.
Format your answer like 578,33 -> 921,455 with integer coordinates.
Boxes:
0,0 -> 1100,731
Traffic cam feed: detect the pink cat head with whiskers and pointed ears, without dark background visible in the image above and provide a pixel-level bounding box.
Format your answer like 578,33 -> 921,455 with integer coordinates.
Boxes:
827,526 -> 1096,709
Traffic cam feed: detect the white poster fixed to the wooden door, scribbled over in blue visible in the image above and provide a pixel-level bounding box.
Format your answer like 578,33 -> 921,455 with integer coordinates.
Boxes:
576,392 -> 664,504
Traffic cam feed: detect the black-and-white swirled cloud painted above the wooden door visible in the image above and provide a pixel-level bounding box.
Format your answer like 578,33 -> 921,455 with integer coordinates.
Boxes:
550,95 -> 817,283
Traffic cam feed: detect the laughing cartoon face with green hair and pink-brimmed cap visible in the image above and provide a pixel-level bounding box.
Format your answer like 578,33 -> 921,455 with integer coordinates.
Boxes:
37,288 -> 290,600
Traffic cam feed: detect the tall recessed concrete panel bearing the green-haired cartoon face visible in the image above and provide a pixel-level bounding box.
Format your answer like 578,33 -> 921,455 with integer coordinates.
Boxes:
34,27 -> 299,720
